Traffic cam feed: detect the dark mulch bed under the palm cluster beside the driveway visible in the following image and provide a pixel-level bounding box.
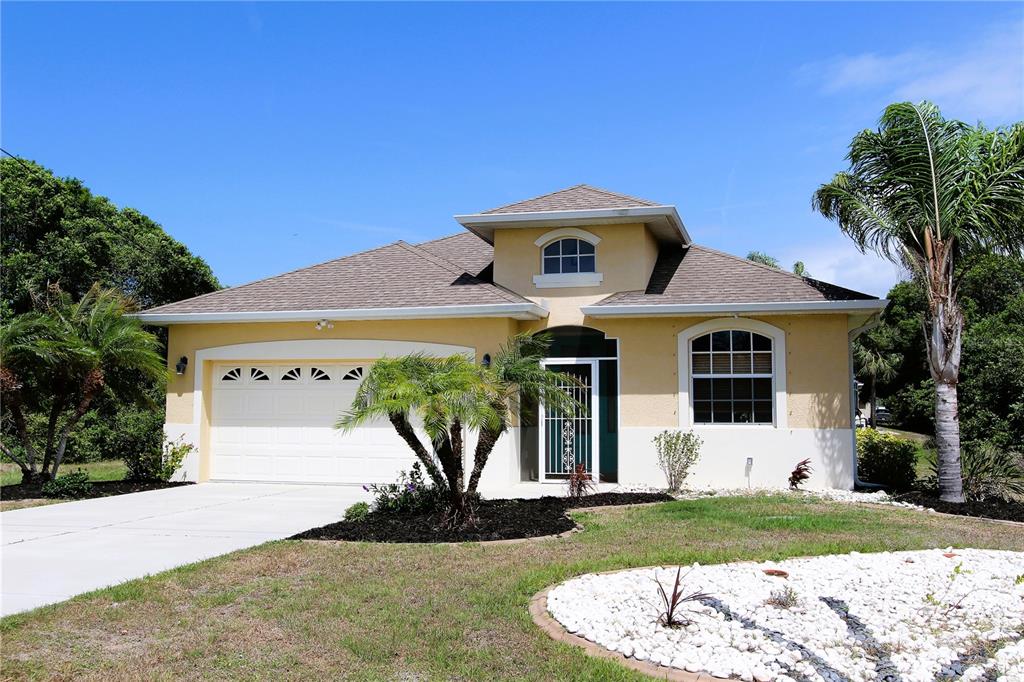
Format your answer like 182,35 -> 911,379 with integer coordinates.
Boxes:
292,493 -> 673,543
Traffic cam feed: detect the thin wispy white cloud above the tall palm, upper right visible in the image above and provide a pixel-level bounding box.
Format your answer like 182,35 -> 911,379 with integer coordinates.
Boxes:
800,20 -> 1024,123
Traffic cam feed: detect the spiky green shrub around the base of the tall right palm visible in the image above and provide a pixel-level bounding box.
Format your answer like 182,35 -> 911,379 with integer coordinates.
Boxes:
926,441 -> 1024,502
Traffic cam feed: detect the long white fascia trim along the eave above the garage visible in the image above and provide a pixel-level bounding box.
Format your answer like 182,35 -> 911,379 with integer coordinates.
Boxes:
133,303 -> 548,326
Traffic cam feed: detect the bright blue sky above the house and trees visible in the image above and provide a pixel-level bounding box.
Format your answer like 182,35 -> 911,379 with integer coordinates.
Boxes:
0,2 -> 1024,294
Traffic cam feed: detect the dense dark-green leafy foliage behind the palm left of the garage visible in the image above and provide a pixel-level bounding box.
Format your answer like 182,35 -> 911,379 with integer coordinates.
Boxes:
0,158 -> 219,481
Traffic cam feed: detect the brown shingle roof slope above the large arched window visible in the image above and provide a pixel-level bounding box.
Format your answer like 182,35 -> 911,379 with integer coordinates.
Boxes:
596,245 -> 878,305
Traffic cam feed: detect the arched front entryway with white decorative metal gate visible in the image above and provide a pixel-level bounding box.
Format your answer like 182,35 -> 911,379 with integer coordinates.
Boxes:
520,327 -> 618,482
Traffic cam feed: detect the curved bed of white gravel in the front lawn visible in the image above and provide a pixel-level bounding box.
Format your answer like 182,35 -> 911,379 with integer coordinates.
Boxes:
548,549 -> 1024,682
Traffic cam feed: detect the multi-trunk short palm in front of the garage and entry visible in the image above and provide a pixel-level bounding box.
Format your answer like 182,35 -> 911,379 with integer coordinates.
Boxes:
337,335 -> 585,524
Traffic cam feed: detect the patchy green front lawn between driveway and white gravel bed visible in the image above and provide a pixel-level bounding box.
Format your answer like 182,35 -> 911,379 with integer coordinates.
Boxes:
0,496 -> 1024,680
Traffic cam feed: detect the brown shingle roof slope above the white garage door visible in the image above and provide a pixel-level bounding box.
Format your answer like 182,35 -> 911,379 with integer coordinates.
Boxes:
145,237 -> 529,314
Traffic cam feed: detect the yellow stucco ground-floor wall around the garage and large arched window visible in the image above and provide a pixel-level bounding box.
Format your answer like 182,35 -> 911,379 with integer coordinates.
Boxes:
167,311 -> 850,428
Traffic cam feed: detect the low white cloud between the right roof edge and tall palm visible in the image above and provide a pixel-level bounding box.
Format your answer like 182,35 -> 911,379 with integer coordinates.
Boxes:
779,238 -> 906,297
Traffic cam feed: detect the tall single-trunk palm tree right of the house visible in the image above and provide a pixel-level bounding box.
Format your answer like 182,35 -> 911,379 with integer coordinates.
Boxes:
812,102 -> 1024,503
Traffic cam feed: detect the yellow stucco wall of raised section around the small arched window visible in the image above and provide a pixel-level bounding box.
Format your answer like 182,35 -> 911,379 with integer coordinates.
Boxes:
495,224 -> 657,300
